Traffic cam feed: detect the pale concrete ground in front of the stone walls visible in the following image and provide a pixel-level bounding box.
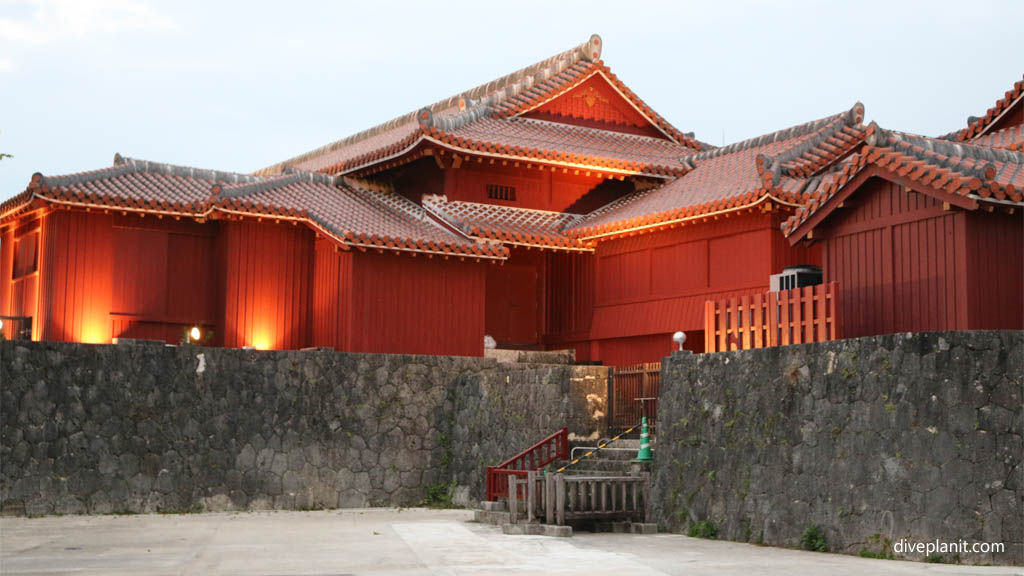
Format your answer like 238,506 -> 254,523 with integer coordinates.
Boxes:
0,508 -> 1024,576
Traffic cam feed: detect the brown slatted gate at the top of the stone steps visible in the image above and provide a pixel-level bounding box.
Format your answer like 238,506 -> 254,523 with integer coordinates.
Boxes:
608,362 -> 662,437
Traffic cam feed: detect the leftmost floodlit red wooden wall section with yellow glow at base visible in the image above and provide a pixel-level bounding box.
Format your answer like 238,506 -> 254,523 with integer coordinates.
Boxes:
34,210 -> 114,343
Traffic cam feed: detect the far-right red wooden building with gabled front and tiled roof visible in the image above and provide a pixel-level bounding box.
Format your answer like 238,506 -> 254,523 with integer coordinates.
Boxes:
782,81 -> 1024,336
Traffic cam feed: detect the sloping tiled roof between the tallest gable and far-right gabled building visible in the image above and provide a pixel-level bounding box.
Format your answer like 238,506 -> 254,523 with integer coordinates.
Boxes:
568,104 -> 864,238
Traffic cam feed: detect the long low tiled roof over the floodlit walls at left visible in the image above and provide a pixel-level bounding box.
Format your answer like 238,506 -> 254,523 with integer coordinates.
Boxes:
0,156 -> 508,259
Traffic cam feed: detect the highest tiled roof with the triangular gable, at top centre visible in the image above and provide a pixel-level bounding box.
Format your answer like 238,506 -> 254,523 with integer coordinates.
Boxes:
257,35 -> 708,177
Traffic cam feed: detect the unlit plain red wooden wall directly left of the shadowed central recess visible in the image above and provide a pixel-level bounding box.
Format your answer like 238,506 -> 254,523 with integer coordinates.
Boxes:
350,252 -> 485,356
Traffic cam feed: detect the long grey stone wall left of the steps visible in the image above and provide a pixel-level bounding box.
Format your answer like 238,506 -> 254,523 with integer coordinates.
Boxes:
0,341 -> 607,515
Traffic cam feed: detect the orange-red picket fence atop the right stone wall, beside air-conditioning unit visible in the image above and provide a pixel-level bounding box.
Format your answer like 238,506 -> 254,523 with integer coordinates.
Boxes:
705,282 -> 842,353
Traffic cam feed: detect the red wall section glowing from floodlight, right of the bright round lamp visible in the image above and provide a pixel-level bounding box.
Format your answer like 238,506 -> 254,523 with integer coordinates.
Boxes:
220,221 -> 313,349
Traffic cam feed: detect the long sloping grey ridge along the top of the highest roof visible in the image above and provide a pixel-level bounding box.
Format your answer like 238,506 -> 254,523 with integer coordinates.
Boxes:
255,34 -> 603,175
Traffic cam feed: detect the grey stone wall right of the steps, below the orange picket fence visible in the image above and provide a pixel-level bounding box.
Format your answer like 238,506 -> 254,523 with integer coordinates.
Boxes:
650,332 -> 1024,564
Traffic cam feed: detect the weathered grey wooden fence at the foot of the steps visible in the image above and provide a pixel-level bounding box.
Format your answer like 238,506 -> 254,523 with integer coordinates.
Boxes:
508,471 -> 650,526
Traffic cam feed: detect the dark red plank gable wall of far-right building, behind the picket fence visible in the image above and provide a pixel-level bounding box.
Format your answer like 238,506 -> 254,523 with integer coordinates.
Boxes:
822,178 -> 970,337
